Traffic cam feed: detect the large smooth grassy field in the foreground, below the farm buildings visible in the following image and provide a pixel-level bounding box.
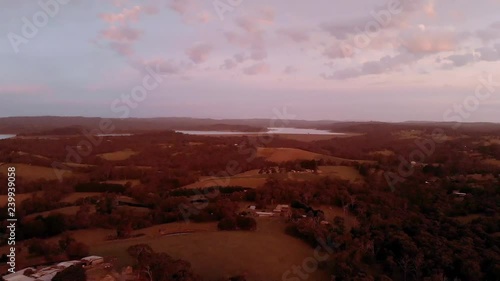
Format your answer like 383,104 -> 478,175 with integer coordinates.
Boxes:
91,218 -> 327,281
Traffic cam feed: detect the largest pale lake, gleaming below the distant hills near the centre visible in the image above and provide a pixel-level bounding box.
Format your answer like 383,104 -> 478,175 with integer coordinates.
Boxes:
176,128 -> 344,136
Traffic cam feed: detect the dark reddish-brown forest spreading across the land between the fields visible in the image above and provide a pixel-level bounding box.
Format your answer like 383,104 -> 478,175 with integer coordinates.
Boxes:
0,121 -> 500,281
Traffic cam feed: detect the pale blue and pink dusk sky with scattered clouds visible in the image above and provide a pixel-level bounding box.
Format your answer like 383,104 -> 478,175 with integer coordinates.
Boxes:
0,0 -> 500,122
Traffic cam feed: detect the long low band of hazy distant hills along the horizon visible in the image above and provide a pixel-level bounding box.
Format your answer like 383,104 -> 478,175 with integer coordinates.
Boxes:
0,116 -> 500,135
